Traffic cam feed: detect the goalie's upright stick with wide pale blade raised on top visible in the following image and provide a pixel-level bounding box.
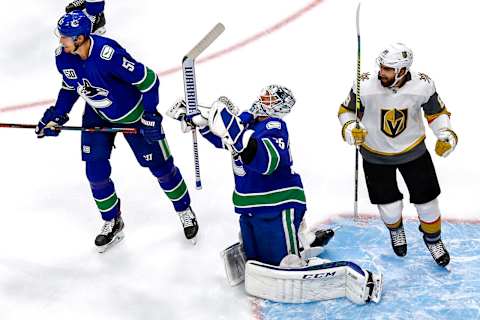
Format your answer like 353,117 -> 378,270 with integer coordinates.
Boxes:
182,23 -> 225,189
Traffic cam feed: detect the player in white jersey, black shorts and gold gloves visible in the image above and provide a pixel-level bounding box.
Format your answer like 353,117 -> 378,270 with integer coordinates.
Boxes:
338,43 -> 458,266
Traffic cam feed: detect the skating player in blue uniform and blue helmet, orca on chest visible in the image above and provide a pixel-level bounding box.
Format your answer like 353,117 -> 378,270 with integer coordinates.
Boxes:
36,11 -> 198,252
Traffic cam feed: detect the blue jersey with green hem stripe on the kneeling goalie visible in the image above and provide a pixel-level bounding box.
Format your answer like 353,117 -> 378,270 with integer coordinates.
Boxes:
200,118 -> 306,214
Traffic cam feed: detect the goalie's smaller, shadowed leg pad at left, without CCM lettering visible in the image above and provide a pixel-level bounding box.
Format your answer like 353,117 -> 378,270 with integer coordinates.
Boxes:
220,242 -> 247,287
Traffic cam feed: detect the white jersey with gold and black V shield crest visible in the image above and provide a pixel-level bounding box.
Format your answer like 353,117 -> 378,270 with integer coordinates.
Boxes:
339,71 -> 450,164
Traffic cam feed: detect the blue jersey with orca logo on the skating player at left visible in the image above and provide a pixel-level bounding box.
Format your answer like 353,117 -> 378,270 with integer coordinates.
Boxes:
55,35 -> 159,124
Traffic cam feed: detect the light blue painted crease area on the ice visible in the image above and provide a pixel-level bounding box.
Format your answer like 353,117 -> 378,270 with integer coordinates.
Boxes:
260,218 -> 480,320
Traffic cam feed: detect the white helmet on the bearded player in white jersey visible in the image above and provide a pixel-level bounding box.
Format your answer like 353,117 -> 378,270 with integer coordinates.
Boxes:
376,42 -> 413,87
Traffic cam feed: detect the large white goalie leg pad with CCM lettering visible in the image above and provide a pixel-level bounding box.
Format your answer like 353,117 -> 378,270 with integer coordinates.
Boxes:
245,260 -> 383,304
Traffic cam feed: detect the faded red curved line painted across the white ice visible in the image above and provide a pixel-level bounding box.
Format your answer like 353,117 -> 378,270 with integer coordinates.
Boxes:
0,0 -> 323,113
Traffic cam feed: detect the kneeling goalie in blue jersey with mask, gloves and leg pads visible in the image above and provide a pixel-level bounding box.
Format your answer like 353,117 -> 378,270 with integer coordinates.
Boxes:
167,85 -> 382,304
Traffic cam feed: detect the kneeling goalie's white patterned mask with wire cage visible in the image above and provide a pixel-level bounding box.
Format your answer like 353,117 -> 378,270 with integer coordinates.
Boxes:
250,85 -> 295,118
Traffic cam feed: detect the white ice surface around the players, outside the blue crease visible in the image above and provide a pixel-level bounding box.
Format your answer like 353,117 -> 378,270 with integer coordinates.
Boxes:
0,0 -> 480,320
